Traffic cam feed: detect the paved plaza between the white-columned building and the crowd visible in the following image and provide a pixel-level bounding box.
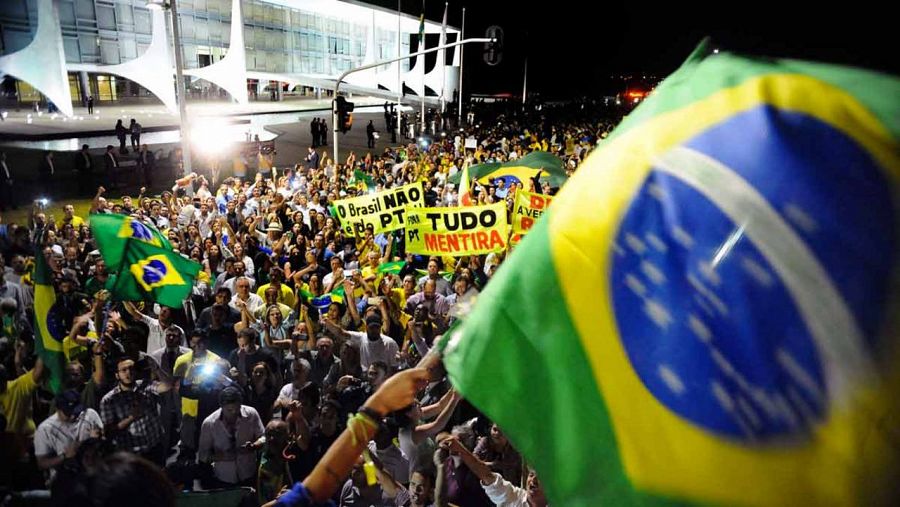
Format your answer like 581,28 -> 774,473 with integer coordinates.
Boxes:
0,90 -> 442,209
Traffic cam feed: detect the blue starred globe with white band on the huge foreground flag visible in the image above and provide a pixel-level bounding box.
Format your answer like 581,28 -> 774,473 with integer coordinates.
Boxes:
611,106 -> 895,444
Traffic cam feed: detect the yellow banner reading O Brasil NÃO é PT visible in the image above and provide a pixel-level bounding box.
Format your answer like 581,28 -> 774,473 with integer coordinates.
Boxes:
334,182 -> 425,236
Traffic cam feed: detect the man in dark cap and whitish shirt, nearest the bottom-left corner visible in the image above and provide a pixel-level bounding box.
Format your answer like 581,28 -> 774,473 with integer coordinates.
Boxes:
34,389 -> 103,478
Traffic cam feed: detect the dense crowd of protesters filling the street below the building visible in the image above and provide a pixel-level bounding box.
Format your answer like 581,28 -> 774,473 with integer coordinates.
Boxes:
0,102 -> 614,506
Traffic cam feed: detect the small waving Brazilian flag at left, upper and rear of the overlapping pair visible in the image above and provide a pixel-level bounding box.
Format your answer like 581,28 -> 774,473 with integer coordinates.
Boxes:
91,213 -> 172,273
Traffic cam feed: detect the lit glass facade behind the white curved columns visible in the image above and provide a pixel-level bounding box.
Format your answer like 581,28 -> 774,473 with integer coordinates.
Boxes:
0,0 -> 409,101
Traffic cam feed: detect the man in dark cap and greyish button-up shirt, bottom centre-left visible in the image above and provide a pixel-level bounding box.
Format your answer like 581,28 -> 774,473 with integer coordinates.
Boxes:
198,386 -> 265,487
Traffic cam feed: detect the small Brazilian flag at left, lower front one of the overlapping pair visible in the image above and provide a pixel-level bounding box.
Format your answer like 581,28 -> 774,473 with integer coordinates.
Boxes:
111,241 -> 201,308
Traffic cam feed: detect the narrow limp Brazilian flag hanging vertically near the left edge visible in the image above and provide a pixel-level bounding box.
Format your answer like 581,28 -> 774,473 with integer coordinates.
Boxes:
32,248 -> 67,393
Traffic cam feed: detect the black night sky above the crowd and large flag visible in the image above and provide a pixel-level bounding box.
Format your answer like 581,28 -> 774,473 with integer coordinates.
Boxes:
370,0 -> 900,97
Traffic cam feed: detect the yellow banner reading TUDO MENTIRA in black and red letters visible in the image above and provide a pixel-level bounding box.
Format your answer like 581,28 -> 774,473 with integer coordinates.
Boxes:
406,202 -> 509,256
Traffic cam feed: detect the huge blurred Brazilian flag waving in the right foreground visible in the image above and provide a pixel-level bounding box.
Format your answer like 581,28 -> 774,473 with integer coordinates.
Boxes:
444,41 -> 900,507
